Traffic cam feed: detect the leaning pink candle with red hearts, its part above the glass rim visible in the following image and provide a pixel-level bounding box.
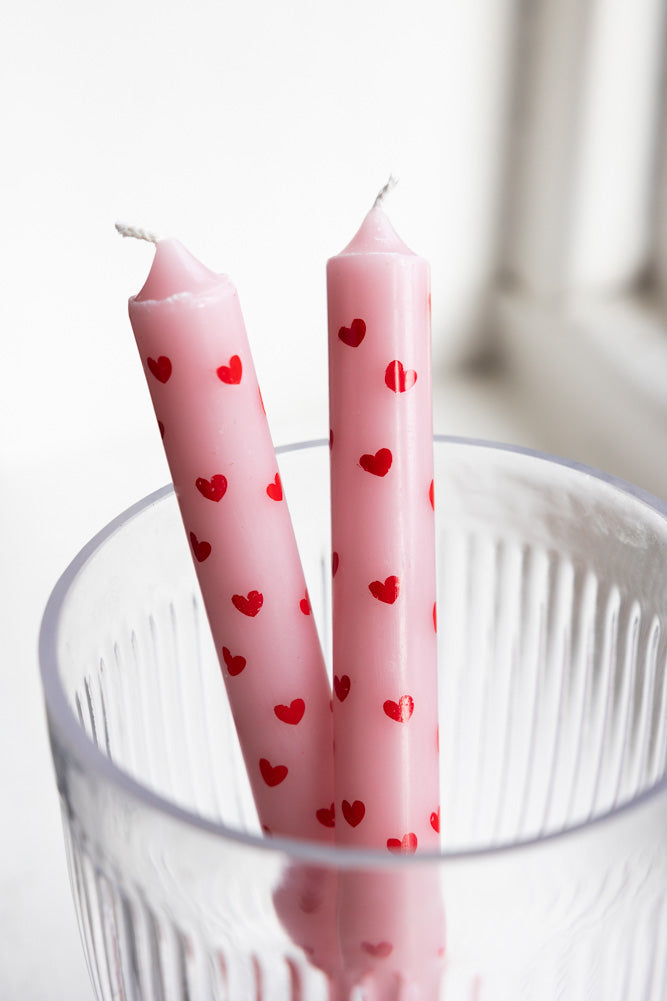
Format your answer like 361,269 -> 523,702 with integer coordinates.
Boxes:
124,240 -> 334,841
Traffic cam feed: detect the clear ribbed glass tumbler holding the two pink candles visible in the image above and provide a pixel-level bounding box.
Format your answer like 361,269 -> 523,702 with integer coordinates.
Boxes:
40,437 -> 667,1001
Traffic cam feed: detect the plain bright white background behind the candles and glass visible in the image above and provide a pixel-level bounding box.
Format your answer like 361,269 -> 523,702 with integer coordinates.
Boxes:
0,0 -> 640,1001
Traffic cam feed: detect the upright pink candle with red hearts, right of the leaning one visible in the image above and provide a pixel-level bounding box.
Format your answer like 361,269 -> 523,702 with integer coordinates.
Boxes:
326,201 -> 445,1001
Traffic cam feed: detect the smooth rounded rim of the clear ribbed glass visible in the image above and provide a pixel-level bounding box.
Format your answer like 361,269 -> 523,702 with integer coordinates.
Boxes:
38,434 -> 667,869
